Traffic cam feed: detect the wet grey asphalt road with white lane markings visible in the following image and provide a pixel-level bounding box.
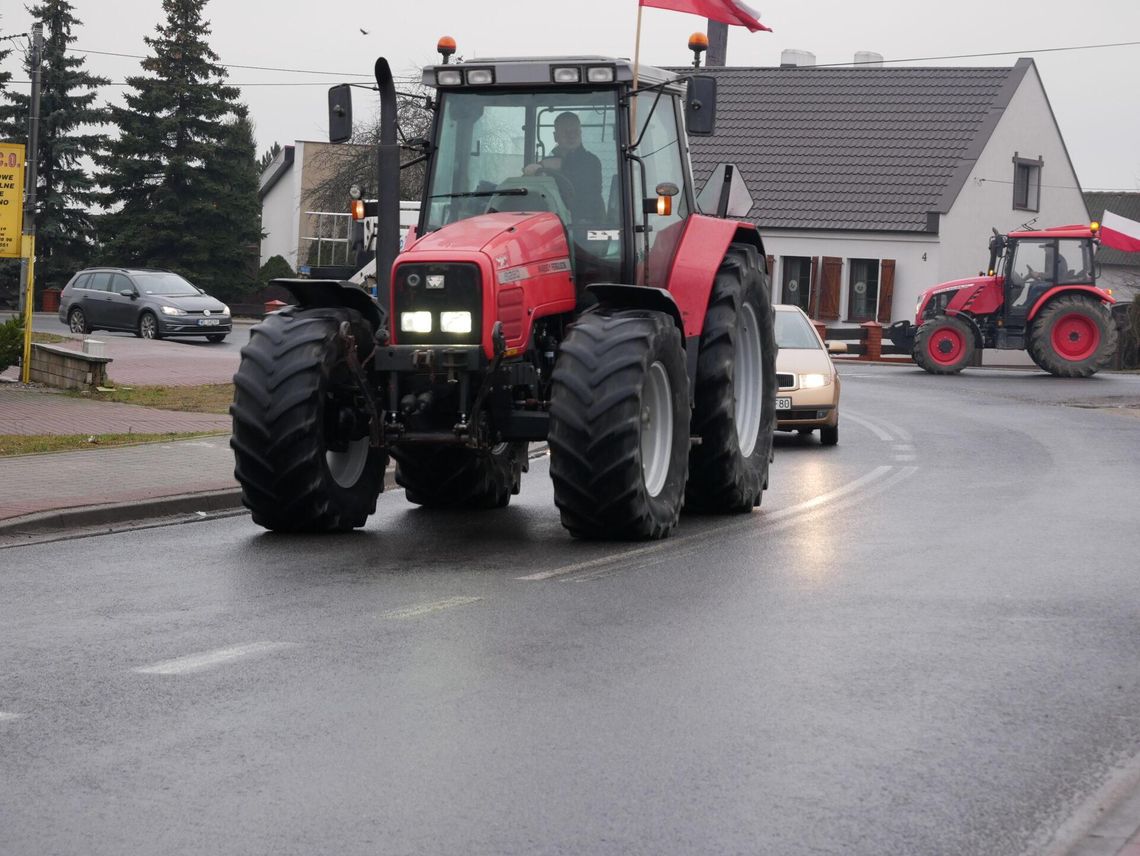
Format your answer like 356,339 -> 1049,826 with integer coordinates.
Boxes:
0,365 -> 1140,856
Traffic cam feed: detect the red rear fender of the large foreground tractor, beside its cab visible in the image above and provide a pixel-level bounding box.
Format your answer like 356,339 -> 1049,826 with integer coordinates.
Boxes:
668,214 -> 764,339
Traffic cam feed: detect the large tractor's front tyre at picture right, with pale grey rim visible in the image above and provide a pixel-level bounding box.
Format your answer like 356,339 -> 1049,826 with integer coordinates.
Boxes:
548,310 -> 690,540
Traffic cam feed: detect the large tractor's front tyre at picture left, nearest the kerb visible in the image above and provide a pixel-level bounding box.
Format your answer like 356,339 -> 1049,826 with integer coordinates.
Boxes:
229,309 -> 388,532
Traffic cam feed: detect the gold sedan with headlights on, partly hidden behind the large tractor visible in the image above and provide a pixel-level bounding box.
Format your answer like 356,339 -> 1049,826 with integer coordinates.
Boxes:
773,304 -> 839,446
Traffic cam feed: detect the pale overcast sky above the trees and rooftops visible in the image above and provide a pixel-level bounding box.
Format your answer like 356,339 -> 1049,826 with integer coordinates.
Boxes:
0,0 -> 1140,190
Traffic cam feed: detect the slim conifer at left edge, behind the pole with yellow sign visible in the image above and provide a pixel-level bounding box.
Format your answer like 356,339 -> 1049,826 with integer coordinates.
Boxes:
0,0 -> 108,292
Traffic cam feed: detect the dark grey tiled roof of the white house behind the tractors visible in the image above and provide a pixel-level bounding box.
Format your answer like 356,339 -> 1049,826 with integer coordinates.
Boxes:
676,59 -> 1031,231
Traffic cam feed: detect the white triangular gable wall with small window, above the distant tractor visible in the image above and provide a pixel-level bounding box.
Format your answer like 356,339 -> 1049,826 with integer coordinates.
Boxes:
931,67 -> 1089,285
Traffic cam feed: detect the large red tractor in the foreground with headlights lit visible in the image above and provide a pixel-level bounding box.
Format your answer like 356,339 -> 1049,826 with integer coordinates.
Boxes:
231,40 -> 776,539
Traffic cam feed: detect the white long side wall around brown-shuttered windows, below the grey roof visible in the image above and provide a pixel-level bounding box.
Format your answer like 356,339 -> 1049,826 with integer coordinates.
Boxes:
760,225 -> 941,324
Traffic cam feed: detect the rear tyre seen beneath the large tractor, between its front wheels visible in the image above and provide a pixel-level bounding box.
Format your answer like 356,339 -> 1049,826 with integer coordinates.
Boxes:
392,442 -> 527,508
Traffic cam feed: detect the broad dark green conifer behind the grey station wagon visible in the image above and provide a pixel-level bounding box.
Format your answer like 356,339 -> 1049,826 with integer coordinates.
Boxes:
99,0 -> 261,291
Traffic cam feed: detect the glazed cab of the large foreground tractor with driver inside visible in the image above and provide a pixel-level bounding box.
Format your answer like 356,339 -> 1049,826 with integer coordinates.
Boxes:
418,57 -> 711,287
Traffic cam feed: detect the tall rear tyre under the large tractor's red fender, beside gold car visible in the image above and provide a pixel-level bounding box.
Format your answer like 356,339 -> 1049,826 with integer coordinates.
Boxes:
685,244 -> 777,513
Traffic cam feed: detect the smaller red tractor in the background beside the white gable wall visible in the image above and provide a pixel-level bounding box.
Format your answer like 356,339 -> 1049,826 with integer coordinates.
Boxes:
888,223 -> 1116,377
